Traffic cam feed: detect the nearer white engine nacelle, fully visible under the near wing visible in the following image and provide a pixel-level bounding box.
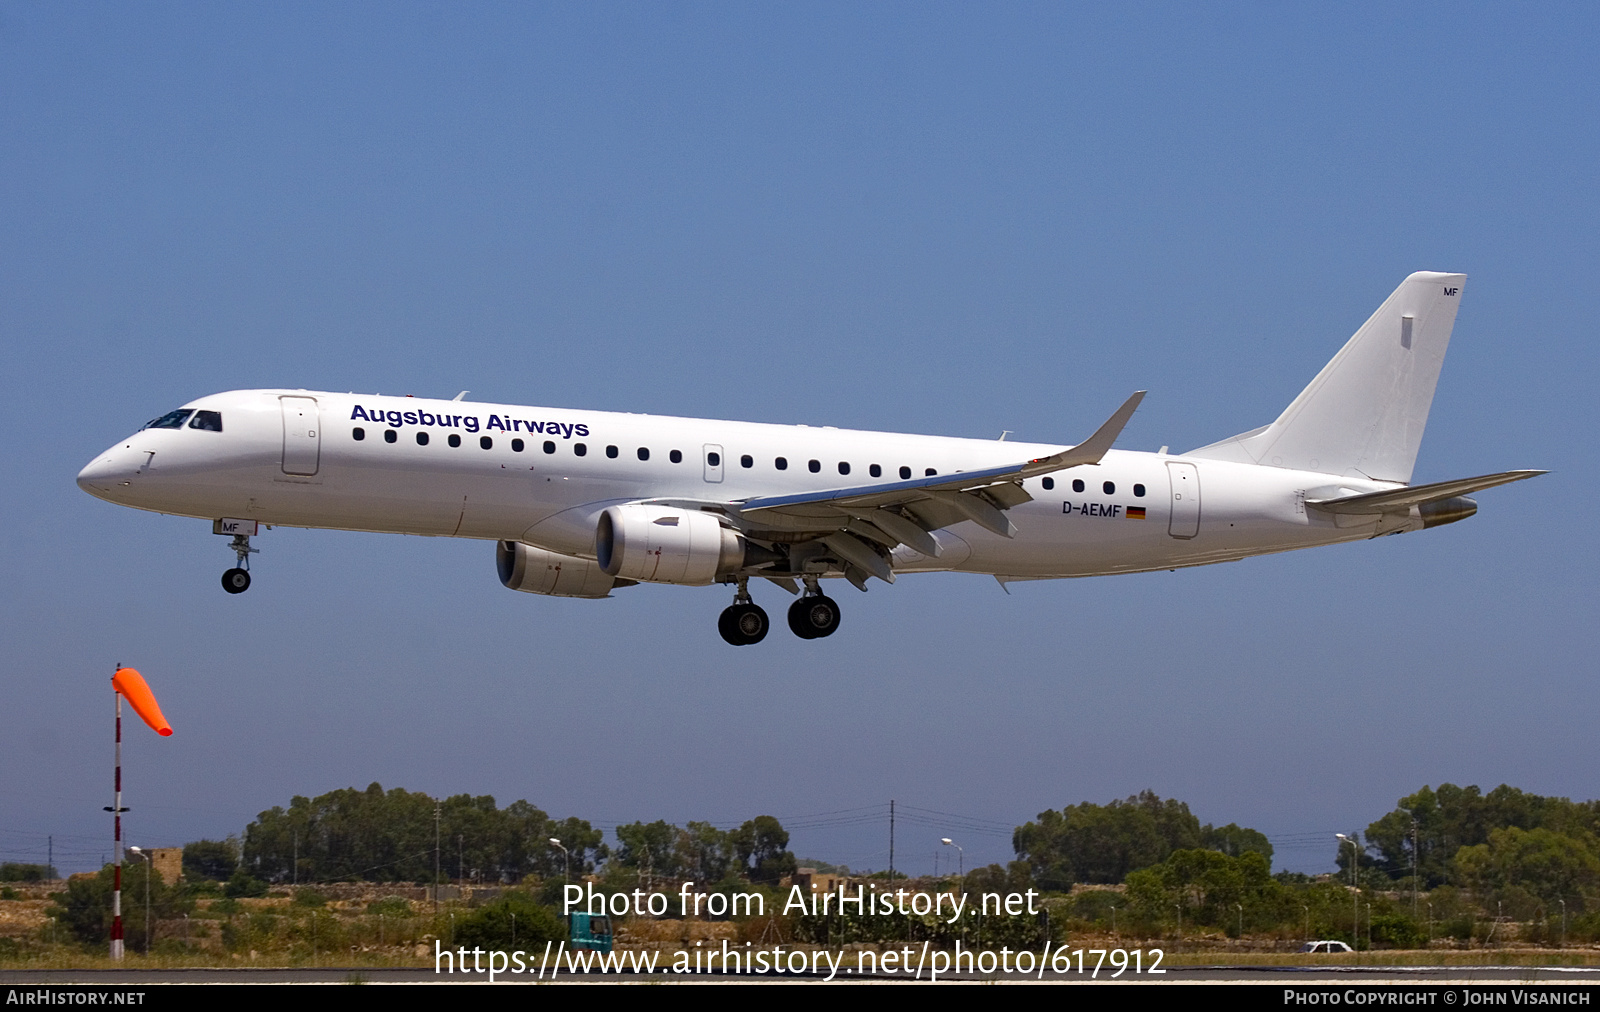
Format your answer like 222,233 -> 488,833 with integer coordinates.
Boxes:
595,506 -> 746,586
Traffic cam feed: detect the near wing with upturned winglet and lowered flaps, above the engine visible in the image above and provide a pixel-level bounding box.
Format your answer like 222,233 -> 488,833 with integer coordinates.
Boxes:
726,391 -> 1144,586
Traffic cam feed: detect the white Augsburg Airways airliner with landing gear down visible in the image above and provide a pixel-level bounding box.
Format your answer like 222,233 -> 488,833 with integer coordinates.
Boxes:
78,272 -> 1544,645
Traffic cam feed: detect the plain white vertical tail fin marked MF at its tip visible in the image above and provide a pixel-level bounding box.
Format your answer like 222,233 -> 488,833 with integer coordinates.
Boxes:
1189,271 -> 1467,482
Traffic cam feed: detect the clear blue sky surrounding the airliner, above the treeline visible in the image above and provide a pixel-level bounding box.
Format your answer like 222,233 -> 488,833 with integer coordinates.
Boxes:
0,0 -> 1600,871
